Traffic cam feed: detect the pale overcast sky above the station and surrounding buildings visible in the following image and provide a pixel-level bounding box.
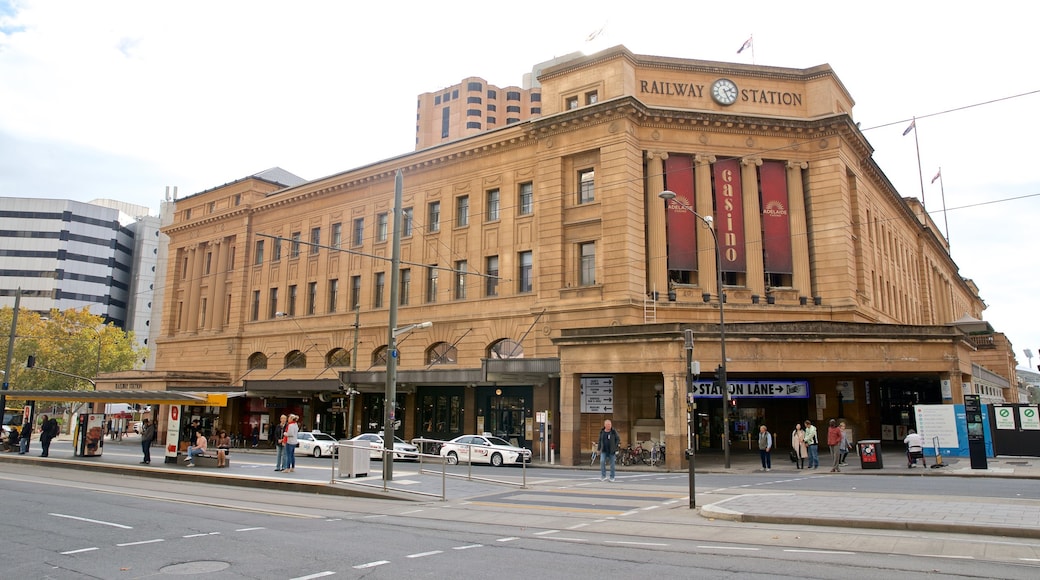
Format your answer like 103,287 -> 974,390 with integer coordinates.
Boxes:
0,0 -> 1040,368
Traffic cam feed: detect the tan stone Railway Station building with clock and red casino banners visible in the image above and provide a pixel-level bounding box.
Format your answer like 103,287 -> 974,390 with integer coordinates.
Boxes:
156,47 -> 1017,467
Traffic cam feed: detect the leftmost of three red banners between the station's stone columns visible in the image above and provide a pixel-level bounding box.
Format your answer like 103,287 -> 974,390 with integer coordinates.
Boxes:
665,155 -> 697,271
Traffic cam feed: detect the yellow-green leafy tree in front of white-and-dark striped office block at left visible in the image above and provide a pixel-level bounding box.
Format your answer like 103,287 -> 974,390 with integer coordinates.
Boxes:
0,307 -> 148,398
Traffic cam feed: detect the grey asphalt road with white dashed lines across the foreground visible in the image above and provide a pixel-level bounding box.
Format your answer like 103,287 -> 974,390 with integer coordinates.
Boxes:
0,459 -> 1040,579
